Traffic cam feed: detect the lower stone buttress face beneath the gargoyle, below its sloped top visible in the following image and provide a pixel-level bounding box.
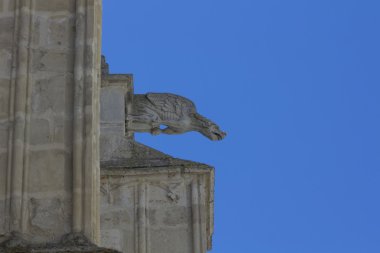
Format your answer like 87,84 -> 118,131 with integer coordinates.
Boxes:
100,162 -> 214,253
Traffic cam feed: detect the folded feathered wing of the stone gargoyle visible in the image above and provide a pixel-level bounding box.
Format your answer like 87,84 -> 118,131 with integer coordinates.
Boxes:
146,93 -> 196,121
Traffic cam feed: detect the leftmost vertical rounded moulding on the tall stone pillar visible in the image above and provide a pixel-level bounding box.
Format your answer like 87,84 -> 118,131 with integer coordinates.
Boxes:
8,0 -> 32,232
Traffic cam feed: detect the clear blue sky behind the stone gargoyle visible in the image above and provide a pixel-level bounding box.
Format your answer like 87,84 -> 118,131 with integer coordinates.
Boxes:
103,0 -> 380,253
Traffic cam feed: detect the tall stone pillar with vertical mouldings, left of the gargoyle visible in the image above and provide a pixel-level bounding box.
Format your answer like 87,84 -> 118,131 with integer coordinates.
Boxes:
0,0 -> 101,242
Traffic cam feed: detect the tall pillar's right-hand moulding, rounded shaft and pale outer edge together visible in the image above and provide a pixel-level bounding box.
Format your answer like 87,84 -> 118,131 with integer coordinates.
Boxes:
72,0 -> 101,242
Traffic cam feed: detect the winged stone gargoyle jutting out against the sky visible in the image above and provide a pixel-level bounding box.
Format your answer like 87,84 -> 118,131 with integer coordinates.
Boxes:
127,93 -> 226,140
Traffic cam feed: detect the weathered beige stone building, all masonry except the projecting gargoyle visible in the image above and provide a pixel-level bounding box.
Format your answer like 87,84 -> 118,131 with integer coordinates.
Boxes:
0,0 -> 218,253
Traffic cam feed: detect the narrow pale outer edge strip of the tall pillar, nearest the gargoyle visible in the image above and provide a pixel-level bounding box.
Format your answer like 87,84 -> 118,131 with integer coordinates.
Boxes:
83,0 -> 101,241
